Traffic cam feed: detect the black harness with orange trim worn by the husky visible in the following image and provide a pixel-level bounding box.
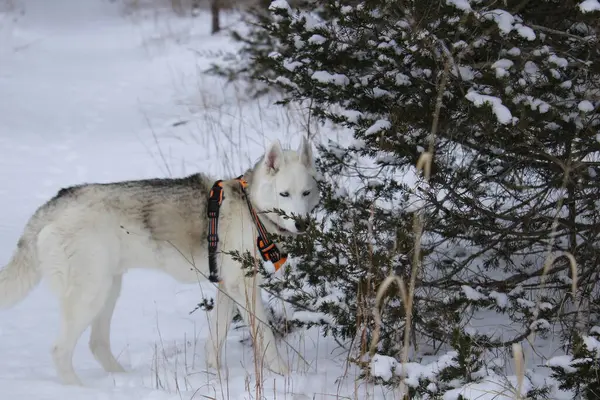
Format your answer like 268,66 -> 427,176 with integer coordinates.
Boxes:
207,176 -> 287,283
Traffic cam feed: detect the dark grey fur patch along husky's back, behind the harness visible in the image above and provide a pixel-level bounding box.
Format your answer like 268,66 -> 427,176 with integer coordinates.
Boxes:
43,174 -> 214,252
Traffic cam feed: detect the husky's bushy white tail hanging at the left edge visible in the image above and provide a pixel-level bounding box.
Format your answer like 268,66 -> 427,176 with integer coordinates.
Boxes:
0,227 -> 42,308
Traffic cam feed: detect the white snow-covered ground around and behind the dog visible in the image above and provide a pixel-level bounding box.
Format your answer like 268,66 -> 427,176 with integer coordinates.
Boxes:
0,0 -> 382,400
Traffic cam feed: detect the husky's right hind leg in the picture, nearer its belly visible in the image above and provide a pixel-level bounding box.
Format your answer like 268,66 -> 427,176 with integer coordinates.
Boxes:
90,275 -> 125,372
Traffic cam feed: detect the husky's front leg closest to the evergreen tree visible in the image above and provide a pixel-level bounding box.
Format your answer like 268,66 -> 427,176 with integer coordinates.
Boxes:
230,277 -> 289,375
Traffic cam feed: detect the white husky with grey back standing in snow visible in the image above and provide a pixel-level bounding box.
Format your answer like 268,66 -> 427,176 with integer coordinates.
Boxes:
0,139 -> 319,384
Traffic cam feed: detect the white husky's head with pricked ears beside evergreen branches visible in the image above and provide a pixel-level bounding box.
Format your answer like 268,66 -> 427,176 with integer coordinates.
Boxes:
252,137 -> 319,235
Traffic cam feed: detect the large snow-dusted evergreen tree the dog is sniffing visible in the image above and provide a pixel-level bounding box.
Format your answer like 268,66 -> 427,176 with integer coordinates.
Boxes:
214,0 -> 600,394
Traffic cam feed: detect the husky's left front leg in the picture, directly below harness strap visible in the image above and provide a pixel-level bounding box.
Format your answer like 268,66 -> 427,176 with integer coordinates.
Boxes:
204,284 -> 235,369
